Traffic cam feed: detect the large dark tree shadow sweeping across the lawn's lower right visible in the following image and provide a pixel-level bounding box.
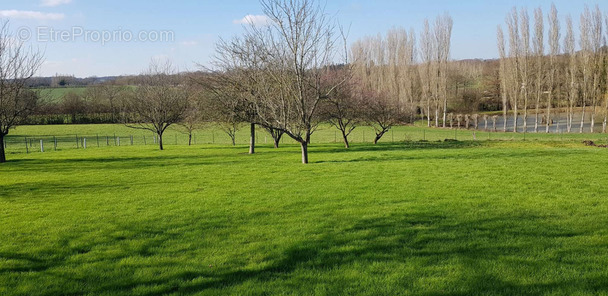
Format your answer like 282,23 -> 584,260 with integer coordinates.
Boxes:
166,214 -> 608,295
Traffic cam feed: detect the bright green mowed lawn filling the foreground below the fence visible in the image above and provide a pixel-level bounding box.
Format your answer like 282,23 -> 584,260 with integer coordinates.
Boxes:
0,141 -> 608,295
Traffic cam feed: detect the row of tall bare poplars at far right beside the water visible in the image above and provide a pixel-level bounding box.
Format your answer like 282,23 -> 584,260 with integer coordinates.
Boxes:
497,5 -> 608,133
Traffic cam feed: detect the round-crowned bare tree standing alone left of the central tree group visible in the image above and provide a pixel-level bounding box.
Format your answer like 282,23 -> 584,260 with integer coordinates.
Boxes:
122,61 -> 188,150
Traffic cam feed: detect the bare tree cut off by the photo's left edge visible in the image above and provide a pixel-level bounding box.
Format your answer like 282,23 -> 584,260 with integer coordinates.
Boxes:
0,21 -> 43,163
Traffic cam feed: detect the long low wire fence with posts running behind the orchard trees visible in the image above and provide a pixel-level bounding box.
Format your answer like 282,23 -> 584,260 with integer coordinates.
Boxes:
4,126 -> 608,153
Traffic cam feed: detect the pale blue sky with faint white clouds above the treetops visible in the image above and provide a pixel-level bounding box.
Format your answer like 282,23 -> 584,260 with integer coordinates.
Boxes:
0,0 -> 608,77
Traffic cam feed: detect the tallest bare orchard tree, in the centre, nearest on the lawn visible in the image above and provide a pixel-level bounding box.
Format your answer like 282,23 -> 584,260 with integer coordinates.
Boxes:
236,0 -> 342,163
